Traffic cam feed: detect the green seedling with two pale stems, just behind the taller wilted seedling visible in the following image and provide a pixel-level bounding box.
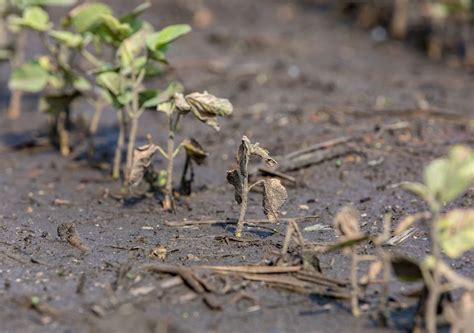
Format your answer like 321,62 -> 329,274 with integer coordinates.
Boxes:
90,8 -> 191,185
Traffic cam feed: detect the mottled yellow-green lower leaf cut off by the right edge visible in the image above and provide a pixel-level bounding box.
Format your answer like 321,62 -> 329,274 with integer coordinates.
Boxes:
435,208 -> 474,258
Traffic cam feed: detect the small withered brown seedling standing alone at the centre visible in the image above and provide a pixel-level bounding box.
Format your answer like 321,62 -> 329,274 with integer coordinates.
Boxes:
227,135 -> 288,237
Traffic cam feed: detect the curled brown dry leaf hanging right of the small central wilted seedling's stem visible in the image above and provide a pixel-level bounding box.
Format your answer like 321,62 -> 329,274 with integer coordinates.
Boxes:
262,178 -> 288,222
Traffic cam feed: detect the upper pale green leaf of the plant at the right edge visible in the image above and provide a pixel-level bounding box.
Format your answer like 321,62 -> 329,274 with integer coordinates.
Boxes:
424,146 -> 474,204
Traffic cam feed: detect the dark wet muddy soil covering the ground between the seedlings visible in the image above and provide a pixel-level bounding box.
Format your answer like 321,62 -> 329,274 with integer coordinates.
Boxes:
0,0 -> 474,333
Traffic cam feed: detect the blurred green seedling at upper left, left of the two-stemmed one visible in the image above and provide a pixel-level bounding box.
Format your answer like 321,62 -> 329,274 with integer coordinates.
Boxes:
9,2 -> 92,156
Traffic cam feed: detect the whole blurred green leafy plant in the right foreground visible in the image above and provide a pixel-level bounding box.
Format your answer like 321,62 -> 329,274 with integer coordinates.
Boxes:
399,146 -> 474,332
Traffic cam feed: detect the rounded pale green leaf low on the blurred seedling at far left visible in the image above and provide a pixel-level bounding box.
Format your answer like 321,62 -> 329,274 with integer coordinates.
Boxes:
9,62 -> 49,93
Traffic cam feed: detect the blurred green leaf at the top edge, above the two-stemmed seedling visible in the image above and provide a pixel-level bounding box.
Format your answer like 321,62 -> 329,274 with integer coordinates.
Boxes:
67,2 -> 112,33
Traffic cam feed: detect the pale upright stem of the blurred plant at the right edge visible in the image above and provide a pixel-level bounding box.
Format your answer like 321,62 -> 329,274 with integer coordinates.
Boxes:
425,210 -> 441,333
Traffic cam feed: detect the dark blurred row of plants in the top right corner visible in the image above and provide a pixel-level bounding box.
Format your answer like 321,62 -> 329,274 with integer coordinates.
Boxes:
301,0 -> 474,67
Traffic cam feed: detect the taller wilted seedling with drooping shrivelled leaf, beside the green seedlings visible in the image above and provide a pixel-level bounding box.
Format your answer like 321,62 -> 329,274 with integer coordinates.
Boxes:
157,89 -> 233,211
